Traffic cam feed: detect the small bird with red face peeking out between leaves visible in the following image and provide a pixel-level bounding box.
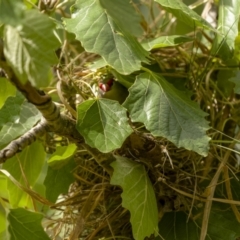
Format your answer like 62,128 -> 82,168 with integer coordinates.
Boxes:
98,79 -> 128,104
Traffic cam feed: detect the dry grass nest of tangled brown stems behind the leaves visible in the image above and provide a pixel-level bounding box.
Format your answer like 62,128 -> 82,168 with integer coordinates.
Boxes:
45,31 -> 240,240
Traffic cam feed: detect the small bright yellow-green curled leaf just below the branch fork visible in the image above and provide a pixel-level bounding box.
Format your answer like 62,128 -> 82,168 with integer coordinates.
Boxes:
48,144 -> 77,164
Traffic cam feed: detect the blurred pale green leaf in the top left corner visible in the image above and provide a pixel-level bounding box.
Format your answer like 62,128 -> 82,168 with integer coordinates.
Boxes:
0,0 -> 24,25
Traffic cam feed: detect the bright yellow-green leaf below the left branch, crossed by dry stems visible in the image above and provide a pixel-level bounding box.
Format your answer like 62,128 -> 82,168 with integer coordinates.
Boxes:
3,141 -> 46,207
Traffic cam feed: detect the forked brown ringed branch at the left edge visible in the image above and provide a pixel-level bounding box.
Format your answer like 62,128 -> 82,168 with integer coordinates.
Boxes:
0,39 -> 84,163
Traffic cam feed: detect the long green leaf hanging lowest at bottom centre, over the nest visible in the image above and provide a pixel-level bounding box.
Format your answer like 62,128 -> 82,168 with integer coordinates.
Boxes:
111,157 -> 158,240
